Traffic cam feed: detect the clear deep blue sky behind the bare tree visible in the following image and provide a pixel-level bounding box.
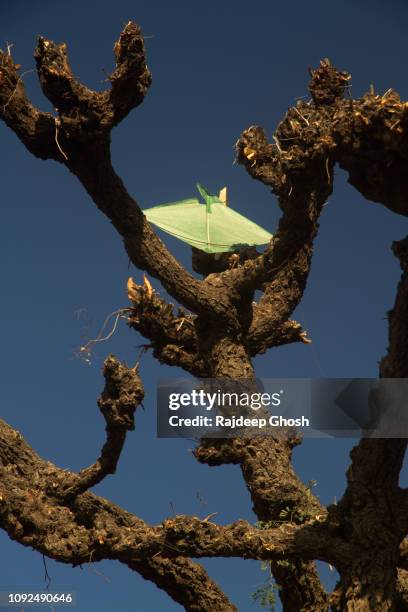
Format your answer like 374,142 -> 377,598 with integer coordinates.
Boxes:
0,0 -> 408,612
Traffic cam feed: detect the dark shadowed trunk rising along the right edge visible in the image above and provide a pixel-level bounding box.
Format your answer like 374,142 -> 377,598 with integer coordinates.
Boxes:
326,239 -> 408,610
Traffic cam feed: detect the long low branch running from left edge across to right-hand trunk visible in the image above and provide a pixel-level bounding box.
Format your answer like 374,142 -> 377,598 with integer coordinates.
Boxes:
0,422 -> 347,564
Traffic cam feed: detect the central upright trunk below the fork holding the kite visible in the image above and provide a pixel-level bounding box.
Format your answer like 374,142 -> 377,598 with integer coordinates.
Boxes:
197,336 -> 328,612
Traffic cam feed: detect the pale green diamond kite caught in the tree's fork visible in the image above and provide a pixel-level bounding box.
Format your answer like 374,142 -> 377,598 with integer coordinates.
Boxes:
143,184 -> 272,253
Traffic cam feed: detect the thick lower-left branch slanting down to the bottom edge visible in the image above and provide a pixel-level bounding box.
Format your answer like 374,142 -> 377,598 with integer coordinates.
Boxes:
0,414 -> 236,612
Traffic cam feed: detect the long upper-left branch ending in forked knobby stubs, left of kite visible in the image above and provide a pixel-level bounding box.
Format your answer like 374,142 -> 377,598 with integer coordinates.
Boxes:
0,22 -> 238,329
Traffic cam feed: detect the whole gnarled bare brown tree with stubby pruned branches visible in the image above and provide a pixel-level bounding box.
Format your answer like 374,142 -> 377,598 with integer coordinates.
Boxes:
0,22 -> 408,612
